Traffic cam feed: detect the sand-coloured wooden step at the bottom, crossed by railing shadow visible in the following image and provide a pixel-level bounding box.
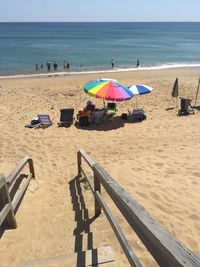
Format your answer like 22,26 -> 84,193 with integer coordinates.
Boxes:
12,246 -> 116,267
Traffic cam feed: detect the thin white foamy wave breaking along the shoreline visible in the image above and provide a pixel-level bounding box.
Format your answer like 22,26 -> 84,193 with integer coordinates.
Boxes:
0,63 -> 200,79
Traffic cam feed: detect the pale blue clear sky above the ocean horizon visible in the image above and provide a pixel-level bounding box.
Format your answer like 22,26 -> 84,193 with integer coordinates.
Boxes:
0,0 -> 200,22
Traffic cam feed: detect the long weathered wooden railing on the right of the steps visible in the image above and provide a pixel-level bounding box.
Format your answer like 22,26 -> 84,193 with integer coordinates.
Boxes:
77,150 -> 200,267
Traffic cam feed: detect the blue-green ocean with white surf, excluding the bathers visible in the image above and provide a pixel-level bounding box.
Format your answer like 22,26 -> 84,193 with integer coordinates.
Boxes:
0,22 -> 200,76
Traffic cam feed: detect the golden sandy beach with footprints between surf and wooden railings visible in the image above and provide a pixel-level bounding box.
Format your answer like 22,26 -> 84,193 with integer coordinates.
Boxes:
0,68 -> 200,267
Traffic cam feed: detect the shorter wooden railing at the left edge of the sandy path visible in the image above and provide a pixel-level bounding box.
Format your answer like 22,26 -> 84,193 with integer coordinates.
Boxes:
0,156 -> 35,228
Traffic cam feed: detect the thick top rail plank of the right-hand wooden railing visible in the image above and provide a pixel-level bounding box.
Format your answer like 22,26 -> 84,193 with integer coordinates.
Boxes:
93,164 -> 200,267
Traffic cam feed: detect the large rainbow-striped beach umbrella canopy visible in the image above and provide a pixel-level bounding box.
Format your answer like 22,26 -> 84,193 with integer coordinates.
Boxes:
84,78 -> 133,102
